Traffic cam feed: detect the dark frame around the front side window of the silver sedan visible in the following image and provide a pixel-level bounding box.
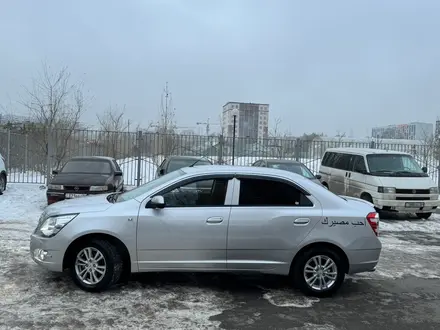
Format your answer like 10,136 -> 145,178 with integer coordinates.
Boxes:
146,173 -> 234,209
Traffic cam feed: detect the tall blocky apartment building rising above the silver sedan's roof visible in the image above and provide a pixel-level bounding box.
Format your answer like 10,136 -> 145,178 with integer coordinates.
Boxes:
222,102 -> 269,139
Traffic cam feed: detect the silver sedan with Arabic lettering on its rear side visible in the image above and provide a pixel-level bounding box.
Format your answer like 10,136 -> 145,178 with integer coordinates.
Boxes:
30,165 -> 382,296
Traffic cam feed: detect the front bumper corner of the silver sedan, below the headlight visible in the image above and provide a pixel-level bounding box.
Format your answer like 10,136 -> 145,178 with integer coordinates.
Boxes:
30,234 -> 64,272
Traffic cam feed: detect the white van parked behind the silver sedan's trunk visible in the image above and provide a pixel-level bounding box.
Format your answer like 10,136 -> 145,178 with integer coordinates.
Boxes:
319,148 -> 440,219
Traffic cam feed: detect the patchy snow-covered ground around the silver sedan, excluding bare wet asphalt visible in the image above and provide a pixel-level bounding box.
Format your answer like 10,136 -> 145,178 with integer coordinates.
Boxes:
0,184 -> 440,329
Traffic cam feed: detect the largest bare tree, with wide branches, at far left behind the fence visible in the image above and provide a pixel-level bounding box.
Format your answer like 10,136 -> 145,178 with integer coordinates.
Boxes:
20,63 -> 85,171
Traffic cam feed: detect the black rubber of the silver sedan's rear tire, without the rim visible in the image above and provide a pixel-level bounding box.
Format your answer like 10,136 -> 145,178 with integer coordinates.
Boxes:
293,248 -> 345,297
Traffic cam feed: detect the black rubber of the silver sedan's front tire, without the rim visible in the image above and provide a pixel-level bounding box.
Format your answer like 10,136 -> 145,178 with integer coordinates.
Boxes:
70,240 -> 117,292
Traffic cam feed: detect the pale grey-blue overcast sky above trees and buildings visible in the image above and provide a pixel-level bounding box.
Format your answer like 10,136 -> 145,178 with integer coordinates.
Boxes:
0,0 -> 440,137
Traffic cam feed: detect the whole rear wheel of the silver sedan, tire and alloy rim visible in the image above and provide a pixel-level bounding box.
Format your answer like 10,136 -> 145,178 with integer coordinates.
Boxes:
292,247 -> 345,297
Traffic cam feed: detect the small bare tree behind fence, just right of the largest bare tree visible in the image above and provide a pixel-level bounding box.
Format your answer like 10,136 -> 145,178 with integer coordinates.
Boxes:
96,106 -> 131,159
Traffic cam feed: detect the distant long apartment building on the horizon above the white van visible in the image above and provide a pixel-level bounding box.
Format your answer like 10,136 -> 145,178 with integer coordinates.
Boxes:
371,122 -> 434,140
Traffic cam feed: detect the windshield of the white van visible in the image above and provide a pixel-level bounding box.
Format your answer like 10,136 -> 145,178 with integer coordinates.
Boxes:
367,154 -> 428,176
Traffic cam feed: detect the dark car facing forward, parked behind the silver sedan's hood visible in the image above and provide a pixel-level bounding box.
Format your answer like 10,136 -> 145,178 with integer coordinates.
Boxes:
46,156 -> 124,204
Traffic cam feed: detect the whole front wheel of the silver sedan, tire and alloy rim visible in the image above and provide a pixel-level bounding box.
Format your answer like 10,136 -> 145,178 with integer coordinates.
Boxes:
69,239 -> 123,292
